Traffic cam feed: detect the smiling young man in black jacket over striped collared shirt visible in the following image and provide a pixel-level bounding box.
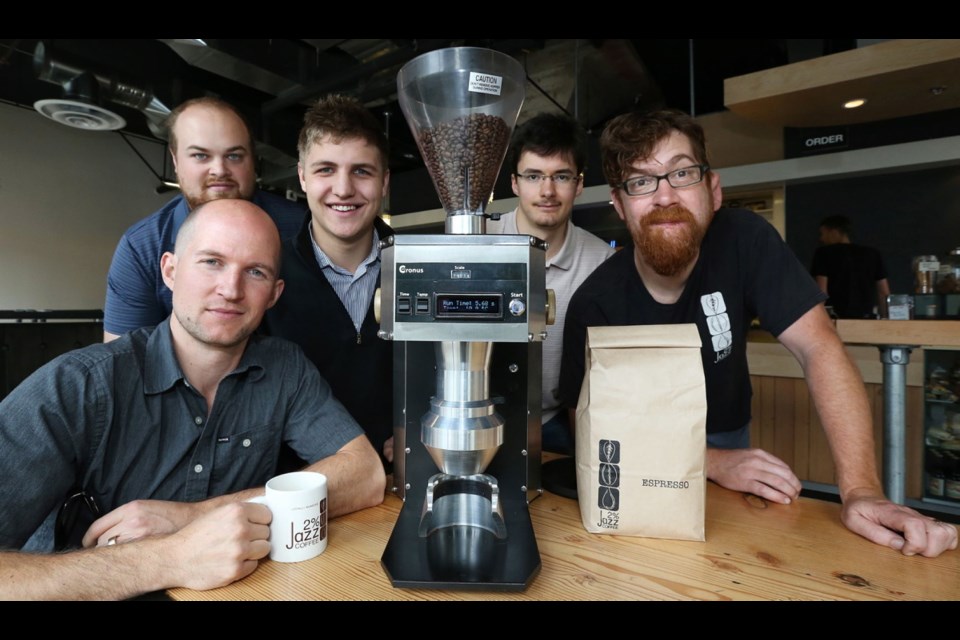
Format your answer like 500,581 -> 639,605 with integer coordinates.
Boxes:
262,95 -> 393,462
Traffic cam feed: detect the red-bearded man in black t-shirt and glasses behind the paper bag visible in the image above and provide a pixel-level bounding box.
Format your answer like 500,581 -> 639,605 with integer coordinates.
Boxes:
560,110 -> 957,556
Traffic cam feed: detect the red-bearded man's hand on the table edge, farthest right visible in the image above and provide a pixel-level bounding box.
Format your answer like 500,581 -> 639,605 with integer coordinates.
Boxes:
840,491 -> 957,558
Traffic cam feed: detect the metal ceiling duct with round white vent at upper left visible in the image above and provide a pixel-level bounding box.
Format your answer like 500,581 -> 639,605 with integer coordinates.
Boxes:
33,42 -> 170,139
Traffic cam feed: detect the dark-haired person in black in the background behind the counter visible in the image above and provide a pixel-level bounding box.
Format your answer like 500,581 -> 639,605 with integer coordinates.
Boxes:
811,216 -> 890,318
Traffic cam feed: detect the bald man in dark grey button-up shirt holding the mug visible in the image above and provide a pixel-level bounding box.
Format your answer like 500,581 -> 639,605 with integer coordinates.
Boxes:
0,200 -> 386,599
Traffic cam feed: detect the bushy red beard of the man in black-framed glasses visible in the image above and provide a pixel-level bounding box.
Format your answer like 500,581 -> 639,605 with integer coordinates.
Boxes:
631,205 -> 706,276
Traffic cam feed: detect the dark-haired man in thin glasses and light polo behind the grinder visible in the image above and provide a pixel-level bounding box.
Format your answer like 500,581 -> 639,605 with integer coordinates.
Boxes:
487,113 -> 614,455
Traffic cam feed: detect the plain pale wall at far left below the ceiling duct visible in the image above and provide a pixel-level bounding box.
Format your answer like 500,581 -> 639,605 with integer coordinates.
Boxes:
0,104 -> 176,310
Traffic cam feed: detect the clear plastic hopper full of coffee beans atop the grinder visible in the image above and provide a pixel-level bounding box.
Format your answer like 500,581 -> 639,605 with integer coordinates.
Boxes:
397,47 -> 526,233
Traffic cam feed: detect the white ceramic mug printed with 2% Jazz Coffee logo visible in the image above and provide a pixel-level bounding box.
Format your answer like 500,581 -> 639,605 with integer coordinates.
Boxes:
248,471 -> 327,562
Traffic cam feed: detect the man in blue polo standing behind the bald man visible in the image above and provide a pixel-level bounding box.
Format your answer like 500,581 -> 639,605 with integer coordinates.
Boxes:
103,97 -> 306,342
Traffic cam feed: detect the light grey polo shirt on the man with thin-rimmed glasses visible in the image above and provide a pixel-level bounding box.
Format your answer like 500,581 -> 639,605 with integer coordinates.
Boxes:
487,209 -> 614,423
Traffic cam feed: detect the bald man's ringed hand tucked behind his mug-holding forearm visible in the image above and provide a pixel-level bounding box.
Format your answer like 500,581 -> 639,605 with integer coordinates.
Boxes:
83,500 -> 205,547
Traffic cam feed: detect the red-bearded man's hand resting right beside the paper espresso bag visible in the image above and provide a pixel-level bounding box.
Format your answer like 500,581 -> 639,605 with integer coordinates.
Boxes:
706,447 -> 803,504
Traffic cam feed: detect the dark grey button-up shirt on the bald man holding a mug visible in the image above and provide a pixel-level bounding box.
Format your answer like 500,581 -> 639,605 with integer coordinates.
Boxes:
0,318 -> 363,549
